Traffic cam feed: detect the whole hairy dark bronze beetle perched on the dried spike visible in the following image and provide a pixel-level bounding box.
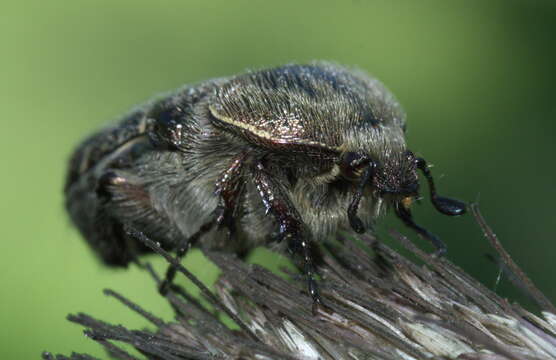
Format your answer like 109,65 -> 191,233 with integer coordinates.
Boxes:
65,63 -> 465,310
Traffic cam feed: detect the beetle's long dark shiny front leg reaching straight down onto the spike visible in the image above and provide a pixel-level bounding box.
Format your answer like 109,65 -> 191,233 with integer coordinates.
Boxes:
253,161 -> 322,313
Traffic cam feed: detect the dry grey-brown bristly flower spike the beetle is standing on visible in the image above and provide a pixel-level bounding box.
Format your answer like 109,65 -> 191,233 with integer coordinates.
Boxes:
43,206 -> 556,360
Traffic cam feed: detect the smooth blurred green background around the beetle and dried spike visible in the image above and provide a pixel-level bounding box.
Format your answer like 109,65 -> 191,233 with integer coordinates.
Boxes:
0,0 -> 556,359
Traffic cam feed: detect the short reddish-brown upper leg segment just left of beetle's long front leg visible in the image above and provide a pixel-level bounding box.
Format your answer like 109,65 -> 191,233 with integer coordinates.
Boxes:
215,153 -> 246,239
